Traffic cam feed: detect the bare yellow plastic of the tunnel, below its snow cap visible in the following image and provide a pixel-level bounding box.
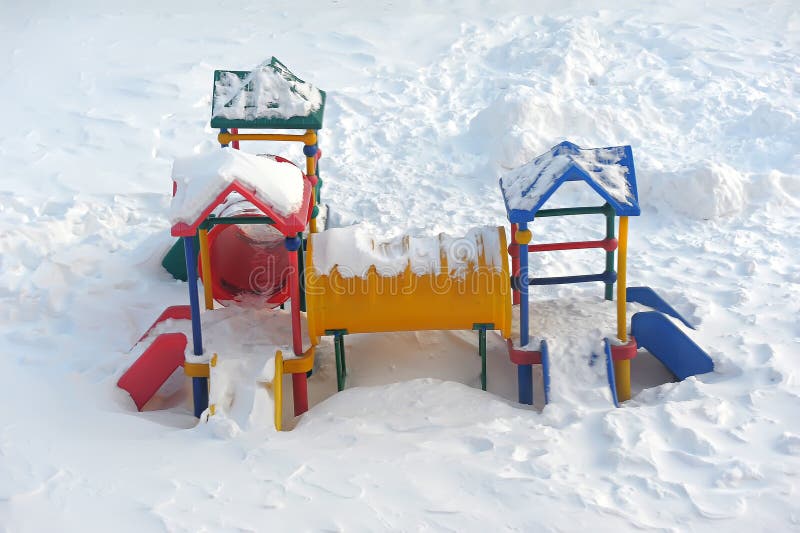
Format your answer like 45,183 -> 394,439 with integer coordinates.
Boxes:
306,227 -> 511,344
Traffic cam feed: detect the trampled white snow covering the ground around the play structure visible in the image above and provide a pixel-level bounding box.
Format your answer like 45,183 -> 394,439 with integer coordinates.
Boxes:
0,0 -> 800,532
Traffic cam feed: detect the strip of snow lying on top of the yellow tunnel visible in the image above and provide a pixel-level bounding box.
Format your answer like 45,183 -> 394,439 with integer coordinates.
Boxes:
311,224 -> 505,278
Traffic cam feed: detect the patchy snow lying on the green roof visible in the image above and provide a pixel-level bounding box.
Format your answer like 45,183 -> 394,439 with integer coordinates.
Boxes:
211,57 -> 323,121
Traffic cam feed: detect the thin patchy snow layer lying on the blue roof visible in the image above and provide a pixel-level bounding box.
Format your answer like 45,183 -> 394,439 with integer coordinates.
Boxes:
500,144 -> 635,211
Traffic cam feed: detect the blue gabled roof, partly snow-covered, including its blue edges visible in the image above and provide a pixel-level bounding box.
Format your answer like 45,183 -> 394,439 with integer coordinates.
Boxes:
500,141 -> 641,222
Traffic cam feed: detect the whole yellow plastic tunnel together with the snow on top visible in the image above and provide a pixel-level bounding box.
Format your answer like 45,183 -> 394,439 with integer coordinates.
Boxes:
306,226 -> 511,344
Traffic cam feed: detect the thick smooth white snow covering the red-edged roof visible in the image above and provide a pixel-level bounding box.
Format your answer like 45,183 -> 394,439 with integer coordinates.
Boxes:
169,148 -> 307,234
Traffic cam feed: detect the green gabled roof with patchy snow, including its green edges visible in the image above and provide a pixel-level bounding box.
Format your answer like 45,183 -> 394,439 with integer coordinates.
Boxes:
211,57 -> 326,130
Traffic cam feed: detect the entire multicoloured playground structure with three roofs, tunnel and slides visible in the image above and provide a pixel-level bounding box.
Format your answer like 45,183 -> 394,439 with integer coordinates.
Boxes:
118,58 -> 714,430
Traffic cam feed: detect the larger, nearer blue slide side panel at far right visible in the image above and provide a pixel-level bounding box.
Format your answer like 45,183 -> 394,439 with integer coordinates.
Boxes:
631,311 -> 714,380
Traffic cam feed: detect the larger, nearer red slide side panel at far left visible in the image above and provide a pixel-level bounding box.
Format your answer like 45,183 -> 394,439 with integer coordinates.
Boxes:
117,333 -> 187,411
